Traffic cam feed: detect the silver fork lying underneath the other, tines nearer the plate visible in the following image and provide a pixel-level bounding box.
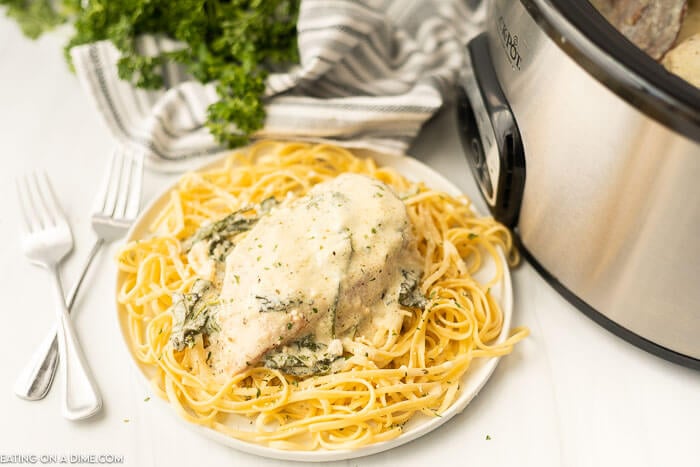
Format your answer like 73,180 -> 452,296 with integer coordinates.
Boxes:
14,150 -> 143,400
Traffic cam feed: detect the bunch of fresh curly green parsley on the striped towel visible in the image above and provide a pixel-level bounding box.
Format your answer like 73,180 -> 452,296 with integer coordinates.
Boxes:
0,0 -> 300,147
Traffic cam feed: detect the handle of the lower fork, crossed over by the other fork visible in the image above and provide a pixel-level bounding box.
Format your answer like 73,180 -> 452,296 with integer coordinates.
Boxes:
14,238 -> 104,401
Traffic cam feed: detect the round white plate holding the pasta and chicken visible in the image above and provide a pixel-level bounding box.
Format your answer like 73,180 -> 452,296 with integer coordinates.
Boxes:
117,150 -> 513,462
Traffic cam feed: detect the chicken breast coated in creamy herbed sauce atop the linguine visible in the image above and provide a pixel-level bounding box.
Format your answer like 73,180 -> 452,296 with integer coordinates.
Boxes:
202,174 -> 421,375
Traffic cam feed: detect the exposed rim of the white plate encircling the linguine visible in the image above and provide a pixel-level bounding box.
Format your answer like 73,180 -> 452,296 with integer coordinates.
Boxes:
115,146 -> 513,462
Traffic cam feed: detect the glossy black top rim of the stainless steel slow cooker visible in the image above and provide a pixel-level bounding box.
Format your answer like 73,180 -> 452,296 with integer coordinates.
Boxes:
520,0 -> 700,143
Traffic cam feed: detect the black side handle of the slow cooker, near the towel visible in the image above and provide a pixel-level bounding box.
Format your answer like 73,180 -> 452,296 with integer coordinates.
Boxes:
457,33 -> 525,227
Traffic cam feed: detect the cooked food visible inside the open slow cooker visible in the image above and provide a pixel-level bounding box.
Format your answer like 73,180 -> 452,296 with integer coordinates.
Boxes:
591,0 -> 700,87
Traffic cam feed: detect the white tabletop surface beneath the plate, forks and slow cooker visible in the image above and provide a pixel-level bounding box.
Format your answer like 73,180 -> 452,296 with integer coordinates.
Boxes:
0,18 -> 700,467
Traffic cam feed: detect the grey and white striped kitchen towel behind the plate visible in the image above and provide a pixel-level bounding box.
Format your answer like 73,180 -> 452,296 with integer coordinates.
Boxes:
72,0 -> 483,171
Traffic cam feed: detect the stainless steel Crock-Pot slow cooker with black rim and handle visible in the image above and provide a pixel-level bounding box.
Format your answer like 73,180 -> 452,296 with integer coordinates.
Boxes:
459,0 -> 700,369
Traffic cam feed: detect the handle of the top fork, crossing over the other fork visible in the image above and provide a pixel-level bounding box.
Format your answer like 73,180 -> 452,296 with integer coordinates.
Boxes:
50,265 -> 102,420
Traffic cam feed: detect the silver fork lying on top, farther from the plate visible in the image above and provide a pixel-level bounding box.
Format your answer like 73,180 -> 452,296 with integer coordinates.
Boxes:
17,173 -> 102,420
